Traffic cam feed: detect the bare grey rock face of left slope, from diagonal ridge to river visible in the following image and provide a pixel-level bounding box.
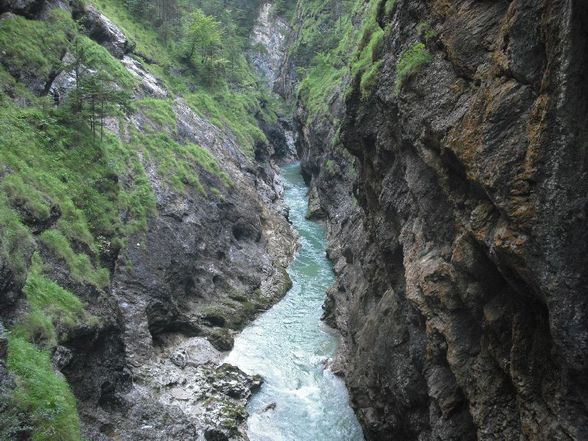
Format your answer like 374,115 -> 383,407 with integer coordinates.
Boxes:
0,0 -> 295,440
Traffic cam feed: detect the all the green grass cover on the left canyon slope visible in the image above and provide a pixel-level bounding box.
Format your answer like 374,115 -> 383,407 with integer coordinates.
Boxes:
0,0 -> 276,441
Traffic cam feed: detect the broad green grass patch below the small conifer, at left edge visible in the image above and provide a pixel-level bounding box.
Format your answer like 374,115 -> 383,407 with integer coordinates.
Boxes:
0,98 -> 155,274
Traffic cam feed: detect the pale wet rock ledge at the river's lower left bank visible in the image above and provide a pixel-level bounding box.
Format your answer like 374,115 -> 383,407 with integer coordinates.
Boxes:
81,337 -> 262,440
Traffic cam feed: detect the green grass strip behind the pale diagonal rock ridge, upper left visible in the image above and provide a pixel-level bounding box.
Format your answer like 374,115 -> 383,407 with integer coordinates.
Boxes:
93,0 -> 277,158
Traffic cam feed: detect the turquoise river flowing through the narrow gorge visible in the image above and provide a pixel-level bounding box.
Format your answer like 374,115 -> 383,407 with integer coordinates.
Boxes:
227,164 -> 363,441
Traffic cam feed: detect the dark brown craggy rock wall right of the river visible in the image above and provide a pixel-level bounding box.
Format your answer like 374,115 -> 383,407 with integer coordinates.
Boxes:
301,0 -> 588,440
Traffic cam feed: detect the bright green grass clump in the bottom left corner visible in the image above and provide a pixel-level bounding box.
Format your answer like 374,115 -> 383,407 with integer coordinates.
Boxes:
8,336 -> 81,441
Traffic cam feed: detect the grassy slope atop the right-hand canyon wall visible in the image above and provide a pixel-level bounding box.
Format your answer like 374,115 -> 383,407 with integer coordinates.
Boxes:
292,0 -> 436,119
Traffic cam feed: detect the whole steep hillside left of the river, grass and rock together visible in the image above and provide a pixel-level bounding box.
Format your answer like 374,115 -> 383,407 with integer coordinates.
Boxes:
0,0 -> 295,441
